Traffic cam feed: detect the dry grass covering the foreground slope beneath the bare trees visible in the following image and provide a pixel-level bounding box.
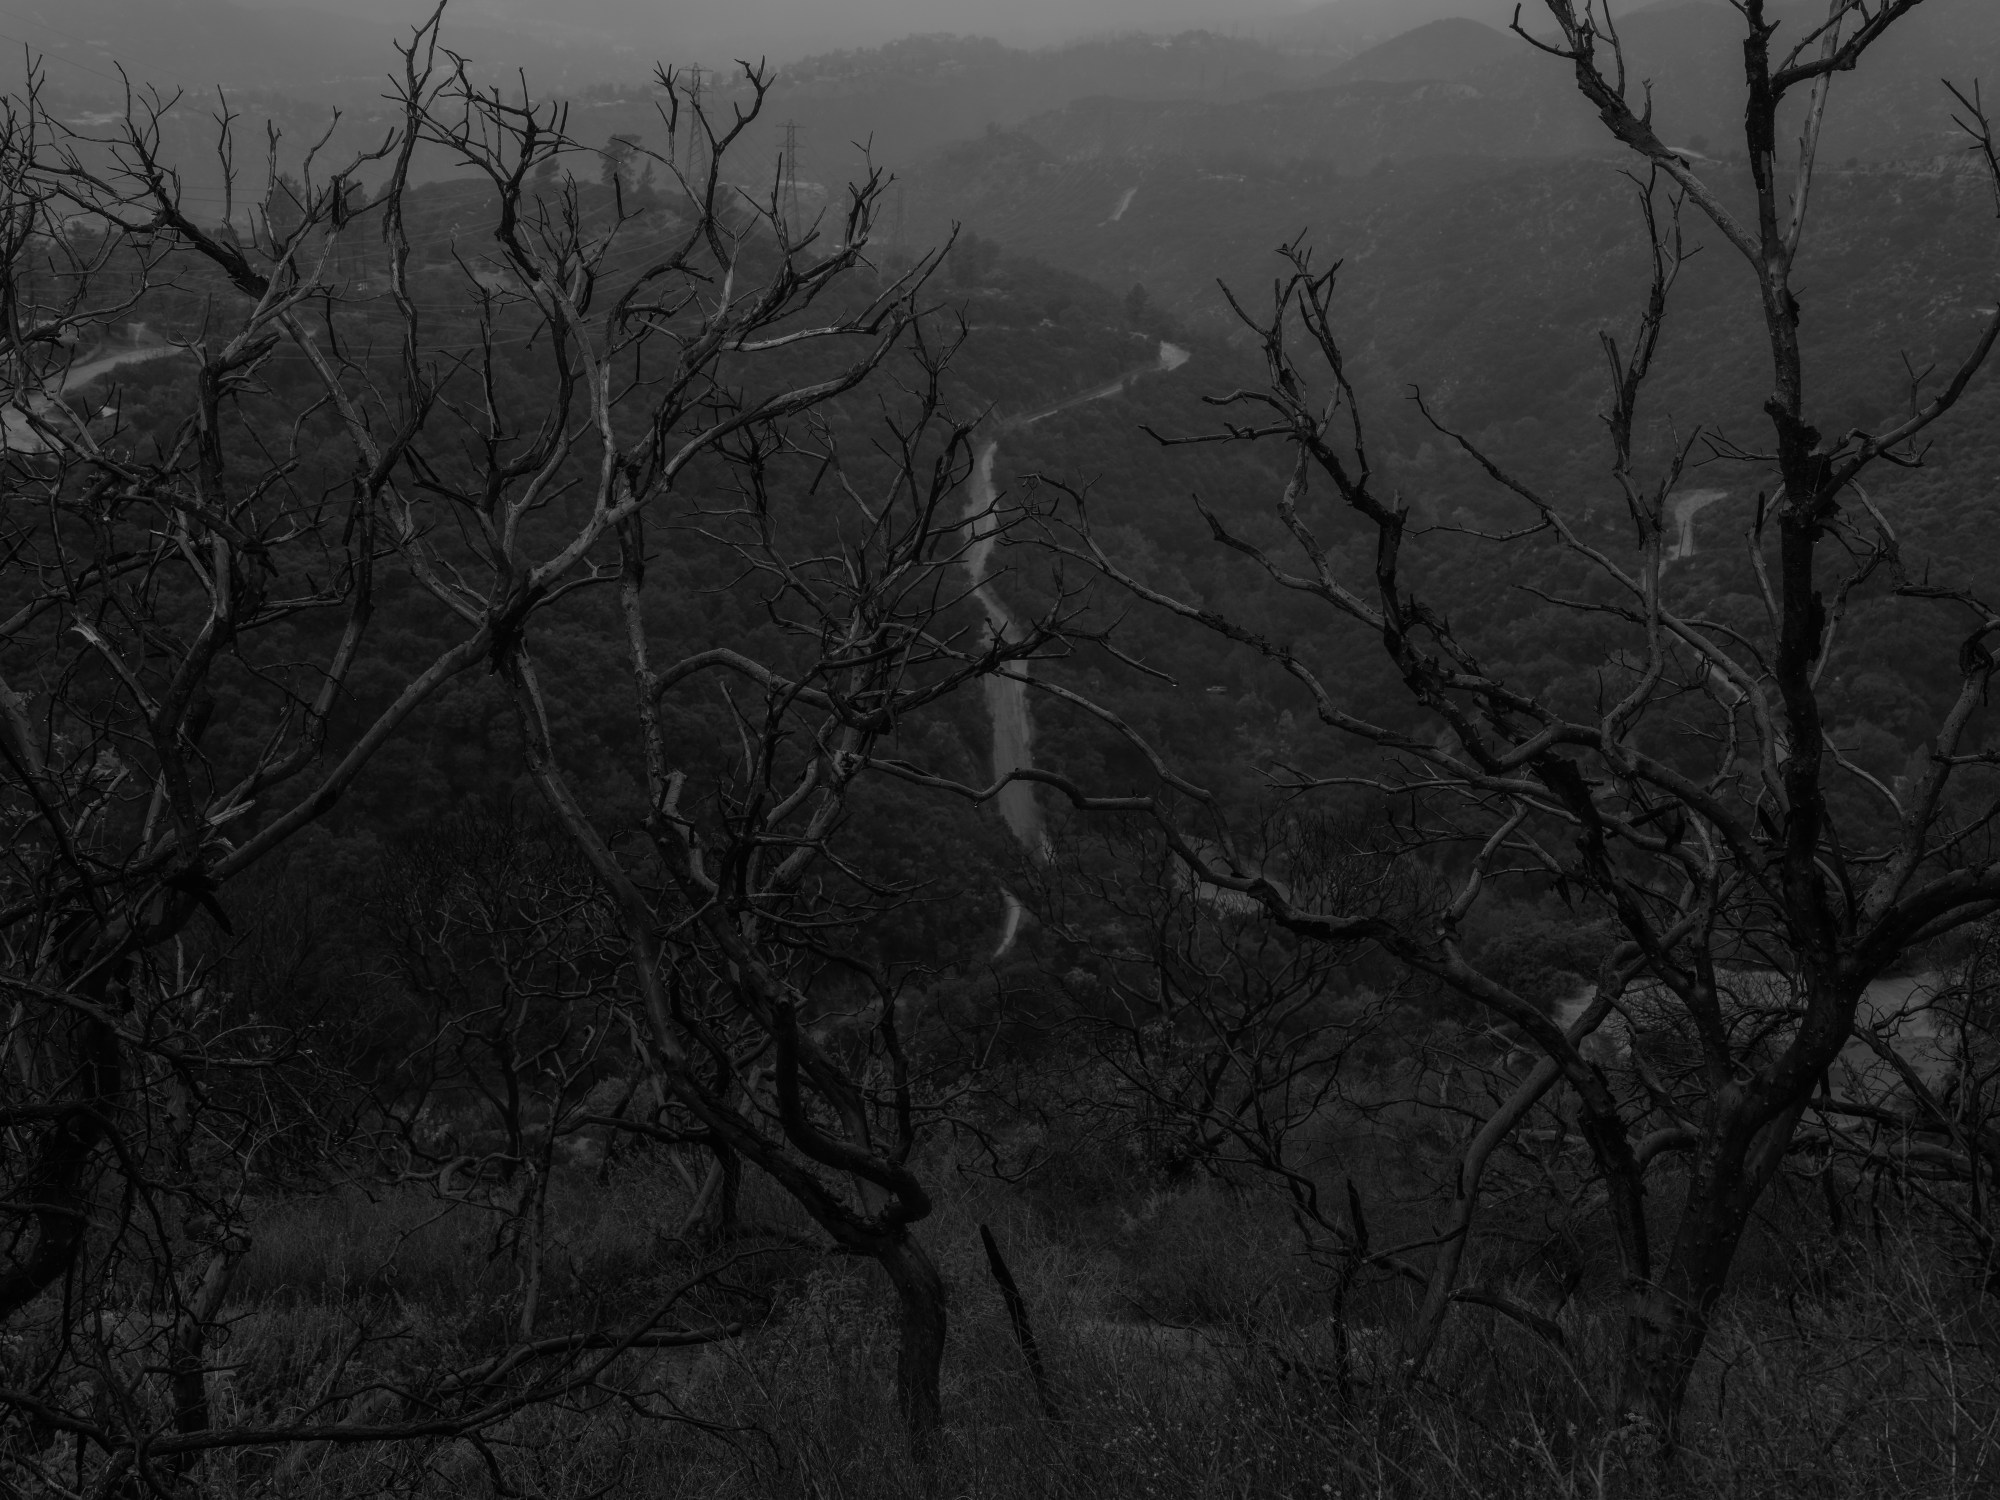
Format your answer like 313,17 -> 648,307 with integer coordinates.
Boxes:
0,1144 -> 2000,1500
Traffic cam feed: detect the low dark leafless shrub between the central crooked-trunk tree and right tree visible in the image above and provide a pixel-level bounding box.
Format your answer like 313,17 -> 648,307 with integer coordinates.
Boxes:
1020,814 -> 1564,1380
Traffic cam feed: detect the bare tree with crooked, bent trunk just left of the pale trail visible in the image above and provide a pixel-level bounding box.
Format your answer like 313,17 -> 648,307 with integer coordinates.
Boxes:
270,11 -> 1064,1438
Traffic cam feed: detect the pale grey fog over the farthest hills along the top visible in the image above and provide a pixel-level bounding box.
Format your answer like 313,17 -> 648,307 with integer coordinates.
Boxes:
19,0 -> 2000,284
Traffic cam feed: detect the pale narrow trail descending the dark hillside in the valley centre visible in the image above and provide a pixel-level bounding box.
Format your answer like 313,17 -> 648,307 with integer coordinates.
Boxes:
964,342 -> 1190,960
